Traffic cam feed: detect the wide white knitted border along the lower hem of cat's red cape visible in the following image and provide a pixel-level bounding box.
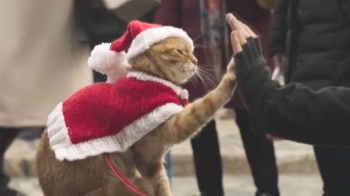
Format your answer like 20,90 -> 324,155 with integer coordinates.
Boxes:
47,103 -> 183,161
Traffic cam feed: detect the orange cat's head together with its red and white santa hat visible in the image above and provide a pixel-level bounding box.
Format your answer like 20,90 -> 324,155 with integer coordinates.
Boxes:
88,21 -> 197,84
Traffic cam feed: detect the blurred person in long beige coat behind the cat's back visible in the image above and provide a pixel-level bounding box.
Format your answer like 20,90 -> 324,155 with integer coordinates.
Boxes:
0,0 -> 92,196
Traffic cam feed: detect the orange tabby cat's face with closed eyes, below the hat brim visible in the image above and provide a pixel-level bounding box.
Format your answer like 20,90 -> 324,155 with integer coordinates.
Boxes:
129,37 -> 197,84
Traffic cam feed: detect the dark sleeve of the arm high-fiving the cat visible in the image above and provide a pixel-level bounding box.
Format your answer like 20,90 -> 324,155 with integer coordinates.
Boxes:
235,39 -> 350,147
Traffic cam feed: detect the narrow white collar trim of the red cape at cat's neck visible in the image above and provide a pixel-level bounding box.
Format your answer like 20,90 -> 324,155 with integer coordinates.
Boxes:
126,71 -> 188,99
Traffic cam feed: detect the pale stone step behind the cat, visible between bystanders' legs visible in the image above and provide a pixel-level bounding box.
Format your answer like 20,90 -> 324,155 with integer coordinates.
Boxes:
5,108 -> 318,178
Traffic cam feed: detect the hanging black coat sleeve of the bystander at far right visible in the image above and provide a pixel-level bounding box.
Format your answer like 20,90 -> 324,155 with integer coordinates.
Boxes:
269,0 -> 290,56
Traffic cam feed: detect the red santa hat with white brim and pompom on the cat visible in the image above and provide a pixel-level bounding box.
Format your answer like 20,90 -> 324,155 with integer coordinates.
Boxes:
88,20 -> 194,83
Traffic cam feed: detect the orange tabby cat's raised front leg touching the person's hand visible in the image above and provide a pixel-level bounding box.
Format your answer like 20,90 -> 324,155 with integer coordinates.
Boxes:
157,61 -> 236,145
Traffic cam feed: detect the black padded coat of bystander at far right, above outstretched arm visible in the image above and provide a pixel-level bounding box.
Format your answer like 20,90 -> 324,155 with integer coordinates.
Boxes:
270,0 -> 350,90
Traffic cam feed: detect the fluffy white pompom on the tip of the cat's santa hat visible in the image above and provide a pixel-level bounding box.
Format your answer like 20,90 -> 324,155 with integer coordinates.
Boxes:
88,43 -> 129,83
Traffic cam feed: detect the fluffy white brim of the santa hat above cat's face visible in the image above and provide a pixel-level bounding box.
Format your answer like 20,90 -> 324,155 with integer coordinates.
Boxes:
127,26 -> 194,60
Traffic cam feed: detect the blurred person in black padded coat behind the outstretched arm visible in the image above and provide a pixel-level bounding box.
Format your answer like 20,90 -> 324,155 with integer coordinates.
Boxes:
270,0 -> 350,196
